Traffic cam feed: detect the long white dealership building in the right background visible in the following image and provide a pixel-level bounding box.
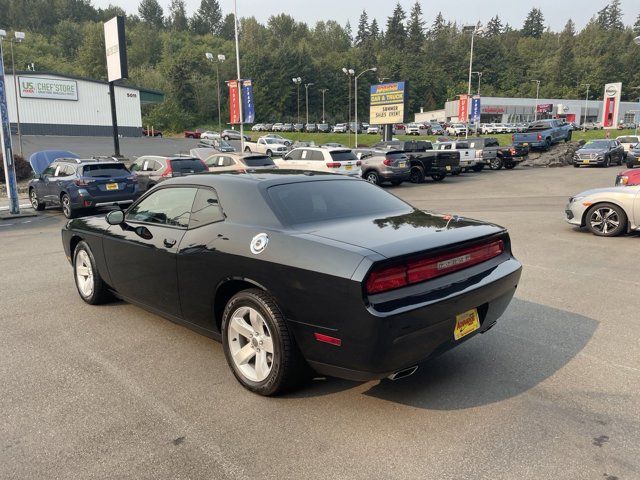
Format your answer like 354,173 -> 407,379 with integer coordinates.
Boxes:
415,97 -> 640,123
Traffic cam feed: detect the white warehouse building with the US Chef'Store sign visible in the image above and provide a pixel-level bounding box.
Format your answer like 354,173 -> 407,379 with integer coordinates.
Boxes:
5,71 -> 164,137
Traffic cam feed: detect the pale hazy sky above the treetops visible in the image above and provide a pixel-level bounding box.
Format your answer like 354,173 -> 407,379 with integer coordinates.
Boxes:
93,0 -> 640,30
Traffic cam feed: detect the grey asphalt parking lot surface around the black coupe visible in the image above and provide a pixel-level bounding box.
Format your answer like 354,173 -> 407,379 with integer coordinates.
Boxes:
0,164 -> 640,480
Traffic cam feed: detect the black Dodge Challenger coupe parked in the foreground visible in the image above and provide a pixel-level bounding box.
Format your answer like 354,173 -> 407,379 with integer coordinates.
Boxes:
62,171 -> 522,395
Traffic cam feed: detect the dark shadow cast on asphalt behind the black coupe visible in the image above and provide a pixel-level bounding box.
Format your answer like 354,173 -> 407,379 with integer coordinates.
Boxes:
289,299 -> 598,410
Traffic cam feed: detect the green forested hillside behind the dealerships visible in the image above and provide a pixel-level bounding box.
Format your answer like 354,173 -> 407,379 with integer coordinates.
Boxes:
0,0 -> 640,130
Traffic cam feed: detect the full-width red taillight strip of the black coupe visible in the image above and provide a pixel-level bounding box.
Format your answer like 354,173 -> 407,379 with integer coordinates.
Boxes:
366,240 -> 504,294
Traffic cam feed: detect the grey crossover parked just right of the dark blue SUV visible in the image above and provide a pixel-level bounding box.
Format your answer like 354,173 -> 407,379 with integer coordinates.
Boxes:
131,155 -> 209,192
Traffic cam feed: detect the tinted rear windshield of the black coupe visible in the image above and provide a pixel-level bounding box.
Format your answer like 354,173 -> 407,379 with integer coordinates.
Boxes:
267,180 -> 412,225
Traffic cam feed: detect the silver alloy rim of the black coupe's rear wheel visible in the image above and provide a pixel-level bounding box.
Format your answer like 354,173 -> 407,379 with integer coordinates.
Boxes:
227,307 -> 273,382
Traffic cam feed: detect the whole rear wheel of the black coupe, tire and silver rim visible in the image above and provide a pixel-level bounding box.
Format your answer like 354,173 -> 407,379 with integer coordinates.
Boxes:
222,289 -> 307,396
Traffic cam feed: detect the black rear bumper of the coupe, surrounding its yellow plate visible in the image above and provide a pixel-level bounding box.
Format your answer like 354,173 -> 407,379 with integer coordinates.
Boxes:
292,254 -> 522,381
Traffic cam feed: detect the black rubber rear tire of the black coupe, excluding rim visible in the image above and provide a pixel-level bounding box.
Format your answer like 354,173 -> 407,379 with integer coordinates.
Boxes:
222,289 -> 309,396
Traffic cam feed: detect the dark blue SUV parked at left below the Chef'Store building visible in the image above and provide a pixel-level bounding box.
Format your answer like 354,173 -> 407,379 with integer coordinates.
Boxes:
29,158 -> 140,218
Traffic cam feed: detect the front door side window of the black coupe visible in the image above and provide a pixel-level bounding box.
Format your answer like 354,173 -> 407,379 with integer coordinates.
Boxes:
126,187 -> 197,228
